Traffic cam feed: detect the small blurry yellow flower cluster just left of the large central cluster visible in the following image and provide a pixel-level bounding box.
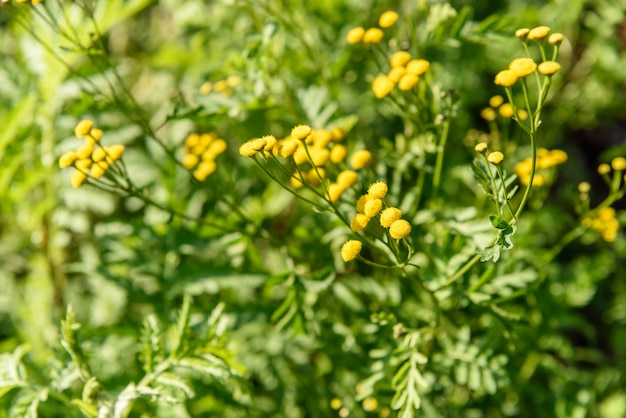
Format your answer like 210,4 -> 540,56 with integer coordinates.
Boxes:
183,133 -> 228,181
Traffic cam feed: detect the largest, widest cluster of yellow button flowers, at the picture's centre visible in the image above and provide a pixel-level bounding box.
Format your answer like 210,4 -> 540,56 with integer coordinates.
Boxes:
239,125 -> 372,203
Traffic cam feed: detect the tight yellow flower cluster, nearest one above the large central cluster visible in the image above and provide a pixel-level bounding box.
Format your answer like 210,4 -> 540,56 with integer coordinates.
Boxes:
372,51 -> 430,99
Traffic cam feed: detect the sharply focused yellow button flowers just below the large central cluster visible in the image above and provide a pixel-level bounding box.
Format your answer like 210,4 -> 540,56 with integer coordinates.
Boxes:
341,181 -> 411,261
